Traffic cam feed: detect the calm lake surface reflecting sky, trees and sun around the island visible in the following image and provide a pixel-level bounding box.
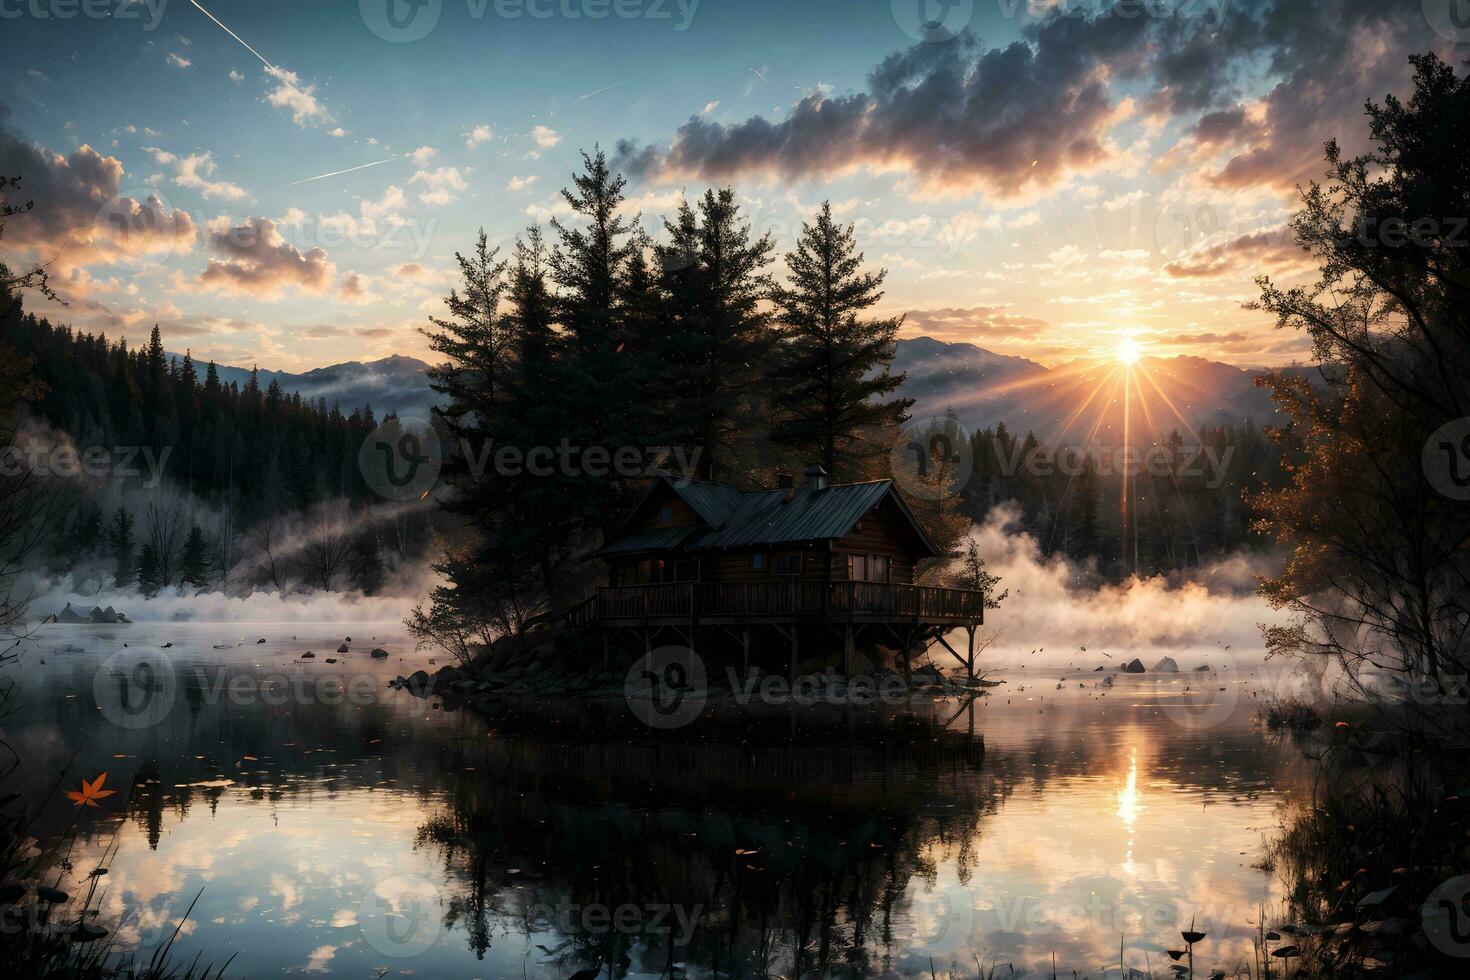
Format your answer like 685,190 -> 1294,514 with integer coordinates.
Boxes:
4,623 -> 1299,977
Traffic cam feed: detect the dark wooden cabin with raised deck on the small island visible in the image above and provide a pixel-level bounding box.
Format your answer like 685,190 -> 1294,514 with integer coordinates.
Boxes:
573,466 -> 985,681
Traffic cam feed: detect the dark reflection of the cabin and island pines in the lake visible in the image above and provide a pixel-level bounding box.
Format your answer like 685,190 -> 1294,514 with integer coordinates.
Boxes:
419,711 -> 1003,977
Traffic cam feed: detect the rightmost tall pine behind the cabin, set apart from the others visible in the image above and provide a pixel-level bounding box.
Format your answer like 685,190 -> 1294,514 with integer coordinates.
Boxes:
772,201 -> 913,478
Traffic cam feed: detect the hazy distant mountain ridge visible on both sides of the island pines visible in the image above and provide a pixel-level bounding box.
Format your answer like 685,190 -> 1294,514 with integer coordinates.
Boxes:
177,336 -> 1293,438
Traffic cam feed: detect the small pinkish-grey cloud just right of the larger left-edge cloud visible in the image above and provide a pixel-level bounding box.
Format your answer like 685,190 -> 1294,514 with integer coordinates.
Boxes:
197,217 -> 337,300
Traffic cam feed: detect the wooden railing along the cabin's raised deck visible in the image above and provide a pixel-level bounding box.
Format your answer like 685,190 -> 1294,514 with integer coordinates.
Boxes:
578,579 -> 985,623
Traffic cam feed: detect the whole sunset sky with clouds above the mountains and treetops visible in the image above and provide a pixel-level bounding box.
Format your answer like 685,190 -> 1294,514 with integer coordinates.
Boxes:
0,0 -> 1470,370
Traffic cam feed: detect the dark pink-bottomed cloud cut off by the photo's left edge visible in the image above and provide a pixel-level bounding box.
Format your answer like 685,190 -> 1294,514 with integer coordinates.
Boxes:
0,103 -> 197,265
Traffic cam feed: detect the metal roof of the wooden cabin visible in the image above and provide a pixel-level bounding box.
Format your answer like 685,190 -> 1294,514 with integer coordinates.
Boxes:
603,478 -> 938,555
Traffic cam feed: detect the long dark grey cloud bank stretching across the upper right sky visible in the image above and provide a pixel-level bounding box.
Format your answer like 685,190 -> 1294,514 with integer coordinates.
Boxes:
616,0 -> 1457,198
